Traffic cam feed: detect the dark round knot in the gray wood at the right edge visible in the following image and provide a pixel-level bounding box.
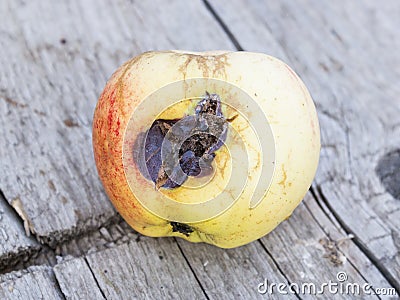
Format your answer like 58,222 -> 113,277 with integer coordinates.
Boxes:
375,149 -> 400,200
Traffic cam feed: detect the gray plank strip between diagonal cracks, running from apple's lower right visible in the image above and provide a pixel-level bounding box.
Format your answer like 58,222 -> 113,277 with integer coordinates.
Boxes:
261,194 -> 382,299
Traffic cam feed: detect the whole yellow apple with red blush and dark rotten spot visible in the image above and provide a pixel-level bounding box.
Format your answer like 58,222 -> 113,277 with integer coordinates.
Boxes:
93,51 -> 320,248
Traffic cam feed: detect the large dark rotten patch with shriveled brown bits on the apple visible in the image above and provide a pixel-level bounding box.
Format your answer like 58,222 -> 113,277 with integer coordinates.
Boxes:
134,93 -> 227,189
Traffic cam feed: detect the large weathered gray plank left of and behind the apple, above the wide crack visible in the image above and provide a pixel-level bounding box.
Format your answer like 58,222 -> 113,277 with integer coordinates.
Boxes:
0,0 -> 232,246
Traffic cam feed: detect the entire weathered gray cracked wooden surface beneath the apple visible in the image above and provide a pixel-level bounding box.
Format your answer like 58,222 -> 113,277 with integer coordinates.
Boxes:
0,0 -> 400,299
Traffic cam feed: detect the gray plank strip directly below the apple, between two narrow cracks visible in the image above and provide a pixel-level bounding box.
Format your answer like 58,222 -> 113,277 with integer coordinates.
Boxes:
178,239 -> 296,299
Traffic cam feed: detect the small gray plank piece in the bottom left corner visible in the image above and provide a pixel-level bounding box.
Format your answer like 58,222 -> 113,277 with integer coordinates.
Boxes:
0,267 -> 64,300
